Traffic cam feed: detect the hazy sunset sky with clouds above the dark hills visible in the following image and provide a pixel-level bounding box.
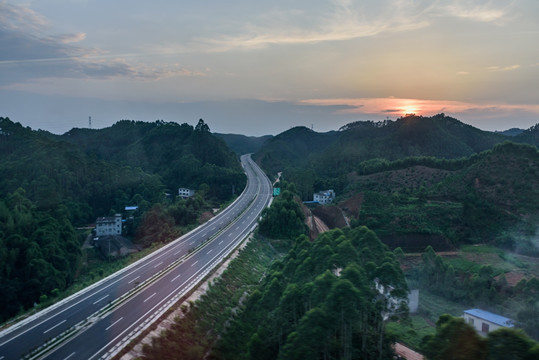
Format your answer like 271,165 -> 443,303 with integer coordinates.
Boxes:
0,0 -> 539,136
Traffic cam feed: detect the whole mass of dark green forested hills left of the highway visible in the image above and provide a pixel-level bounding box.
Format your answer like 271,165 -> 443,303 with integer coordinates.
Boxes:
0,117 -> 246,321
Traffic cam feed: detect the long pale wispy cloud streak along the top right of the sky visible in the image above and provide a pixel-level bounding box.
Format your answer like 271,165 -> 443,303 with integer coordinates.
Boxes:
202,0 -> 510,51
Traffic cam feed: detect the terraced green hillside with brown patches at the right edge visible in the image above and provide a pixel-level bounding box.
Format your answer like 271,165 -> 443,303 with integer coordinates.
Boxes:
342,142 -> 539,255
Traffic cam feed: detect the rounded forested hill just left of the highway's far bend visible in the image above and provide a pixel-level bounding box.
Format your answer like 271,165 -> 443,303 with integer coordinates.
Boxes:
61,119 -> 245,200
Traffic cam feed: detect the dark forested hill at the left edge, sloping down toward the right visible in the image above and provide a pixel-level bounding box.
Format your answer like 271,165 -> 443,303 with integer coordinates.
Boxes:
0,118 -> 160,225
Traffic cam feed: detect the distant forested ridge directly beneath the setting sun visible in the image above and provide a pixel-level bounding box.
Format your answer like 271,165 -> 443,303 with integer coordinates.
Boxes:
255,114 -> 535,177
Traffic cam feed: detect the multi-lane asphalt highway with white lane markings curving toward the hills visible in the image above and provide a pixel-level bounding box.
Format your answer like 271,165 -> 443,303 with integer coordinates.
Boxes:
0,155 -> 272,360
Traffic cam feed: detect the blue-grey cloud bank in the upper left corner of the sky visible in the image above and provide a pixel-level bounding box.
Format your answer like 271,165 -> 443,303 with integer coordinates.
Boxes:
0,2 -> 204,86
